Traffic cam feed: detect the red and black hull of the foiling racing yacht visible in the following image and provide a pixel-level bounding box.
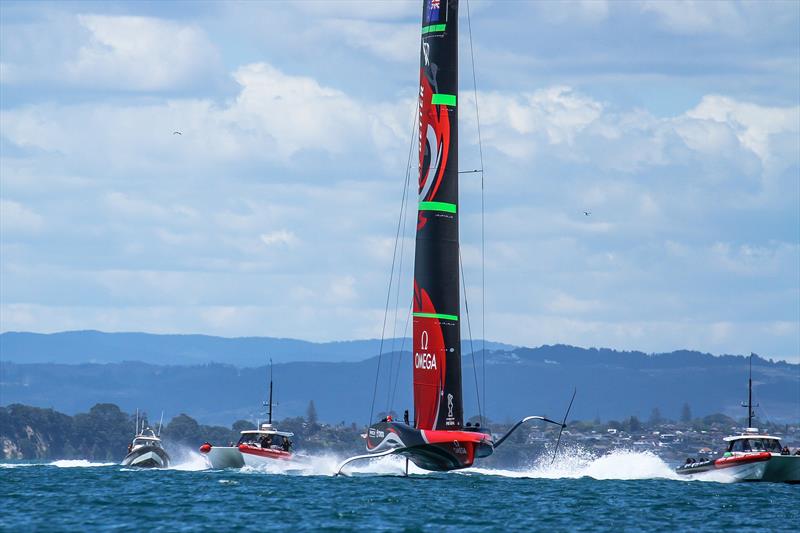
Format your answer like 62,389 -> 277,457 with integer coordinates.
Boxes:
367,422 -> 494,472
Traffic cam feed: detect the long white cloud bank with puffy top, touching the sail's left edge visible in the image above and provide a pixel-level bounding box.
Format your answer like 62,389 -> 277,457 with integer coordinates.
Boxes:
2,63 -> 412,172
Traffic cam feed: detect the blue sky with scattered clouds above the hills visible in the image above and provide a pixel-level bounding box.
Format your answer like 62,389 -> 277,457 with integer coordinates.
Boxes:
0,0 -> 800,361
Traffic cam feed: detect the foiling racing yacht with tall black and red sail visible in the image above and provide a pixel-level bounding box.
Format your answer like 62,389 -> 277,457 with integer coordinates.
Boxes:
339,0 -> 564,473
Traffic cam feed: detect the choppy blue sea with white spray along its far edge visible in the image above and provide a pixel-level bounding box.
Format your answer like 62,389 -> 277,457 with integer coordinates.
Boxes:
0,451 -> 800,532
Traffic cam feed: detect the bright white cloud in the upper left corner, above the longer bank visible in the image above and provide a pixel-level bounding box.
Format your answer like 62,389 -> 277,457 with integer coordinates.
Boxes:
2,14 -> 220,91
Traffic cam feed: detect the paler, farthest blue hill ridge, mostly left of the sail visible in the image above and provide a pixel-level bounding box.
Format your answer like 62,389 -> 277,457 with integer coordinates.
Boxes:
0,331 -> 514,366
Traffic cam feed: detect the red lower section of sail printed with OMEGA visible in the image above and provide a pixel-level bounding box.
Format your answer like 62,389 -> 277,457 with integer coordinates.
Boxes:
414,282 -> 447,429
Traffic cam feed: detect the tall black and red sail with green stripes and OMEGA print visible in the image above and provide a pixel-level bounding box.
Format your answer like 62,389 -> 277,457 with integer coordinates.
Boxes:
413,0 -> 463,429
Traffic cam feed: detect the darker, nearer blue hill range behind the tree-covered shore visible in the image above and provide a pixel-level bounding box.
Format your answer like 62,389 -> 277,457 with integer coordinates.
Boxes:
0,345 -> 800,425
